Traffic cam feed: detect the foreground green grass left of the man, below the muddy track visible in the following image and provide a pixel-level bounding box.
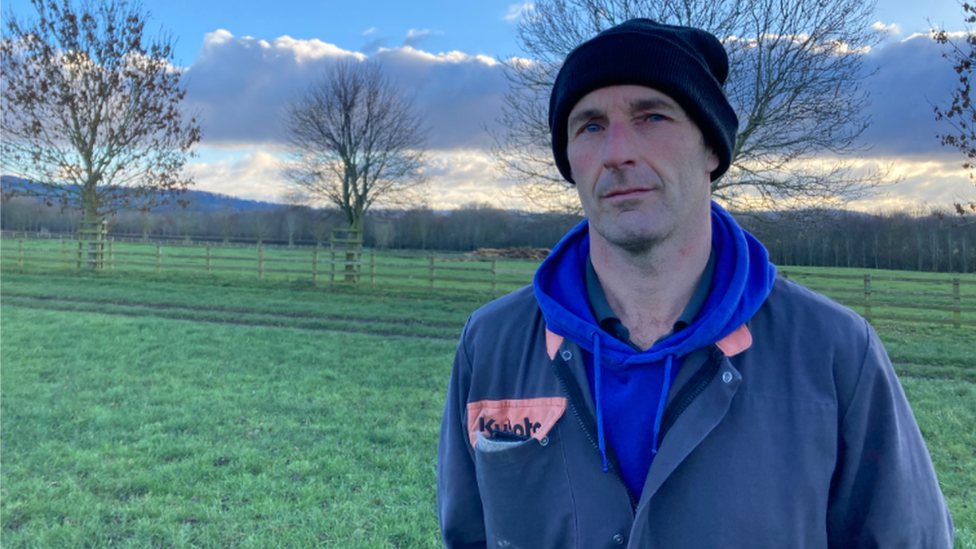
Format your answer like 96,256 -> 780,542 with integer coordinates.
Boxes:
0,306 -> 455,548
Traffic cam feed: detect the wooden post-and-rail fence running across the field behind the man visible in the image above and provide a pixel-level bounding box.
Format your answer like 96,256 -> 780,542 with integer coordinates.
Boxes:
0,234 -> 976,327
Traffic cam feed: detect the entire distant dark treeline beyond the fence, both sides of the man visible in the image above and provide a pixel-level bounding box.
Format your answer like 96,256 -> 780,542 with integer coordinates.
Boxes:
0,199 -> 976,273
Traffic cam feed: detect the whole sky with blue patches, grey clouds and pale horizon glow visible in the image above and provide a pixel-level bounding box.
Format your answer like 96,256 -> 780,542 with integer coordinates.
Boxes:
0,0 -> 976,211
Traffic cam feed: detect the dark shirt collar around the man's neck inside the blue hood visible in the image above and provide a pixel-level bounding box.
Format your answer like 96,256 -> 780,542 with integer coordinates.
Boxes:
584,250 -> 715,352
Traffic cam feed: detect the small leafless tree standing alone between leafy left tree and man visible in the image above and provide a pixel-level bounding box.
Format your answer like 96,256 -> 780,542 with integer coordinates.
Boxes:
284,60 -> 427,228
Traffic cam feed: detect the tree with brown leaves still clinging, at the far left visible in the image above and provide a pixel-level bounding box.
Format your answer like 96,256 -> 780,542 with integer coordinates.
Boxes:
0,0 -> 201,222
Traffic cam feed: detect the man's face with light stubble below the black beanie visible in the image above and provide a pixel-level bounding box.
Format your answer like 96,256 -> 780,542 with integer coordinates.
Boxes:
566,85 -> 718,253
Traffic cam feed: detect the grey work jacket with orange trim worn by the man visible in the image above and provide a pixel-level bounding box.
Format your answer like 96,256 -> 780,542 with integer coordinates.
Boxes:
437,278 -> 953,549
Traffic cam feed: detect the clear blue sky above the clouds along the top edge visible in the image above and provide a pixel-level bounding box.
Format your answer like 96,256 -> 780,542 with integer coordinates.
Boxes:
63,0 -> 976,64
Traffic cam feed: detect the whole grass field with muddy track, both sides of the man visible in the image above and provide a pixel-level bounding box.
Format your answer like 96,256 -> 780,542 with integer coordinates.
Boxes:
0,264 -> 976,549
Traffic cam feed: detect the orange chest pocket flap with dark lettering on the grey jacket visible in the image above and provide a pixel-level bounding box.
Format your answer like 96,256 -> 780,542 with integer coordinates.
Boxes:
468,397 -> 566,447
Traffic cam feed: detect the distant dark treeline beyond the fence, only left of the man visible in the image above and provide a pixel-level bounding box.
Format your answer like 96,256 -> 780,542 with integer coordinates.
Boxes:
0,198 -> 581,252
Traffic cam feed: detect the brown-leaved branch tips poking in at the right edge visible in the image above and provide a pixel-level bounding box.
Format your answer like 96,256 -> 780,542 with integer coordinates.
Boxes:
932,4 -> 976,224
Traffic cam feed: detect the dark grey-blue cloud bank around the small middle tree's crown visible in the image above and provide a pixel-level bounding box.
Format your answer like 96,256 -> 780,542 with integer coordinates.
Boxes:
178,31 -> 508,150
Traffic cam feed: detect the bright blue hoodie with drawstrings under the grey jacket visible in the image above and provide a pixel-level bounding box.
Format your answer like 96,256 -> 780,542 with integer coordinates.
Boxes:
533,202 -> 776,497
